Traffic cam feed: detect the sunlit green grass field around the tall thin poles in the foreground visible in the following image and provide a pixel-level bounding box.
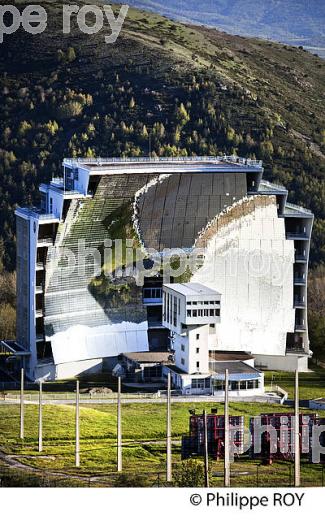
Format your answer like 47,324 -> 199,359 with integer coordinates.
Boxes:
0,396 -> 325,486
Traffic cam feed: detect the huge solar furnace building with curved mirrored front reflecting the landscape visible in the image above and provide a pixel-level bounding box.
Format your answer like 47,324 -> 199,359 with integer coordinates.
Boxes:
9,157 -> 313,379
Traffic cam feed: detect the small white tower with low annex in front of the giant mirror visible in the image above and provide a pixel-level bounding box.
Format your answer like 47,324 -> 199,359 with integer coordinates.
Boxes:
163,283 -> 264,396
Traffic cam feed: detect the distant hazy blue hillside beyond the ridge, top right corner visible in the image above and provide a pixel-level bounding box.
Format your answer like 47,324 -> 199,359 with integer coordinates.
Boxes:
129,0 -> 325,58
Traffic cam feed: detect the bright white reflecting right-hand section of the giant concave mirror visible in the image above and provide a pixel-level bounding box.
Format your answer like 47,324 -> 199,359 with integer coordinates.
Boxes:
191,197 -> 295,356
